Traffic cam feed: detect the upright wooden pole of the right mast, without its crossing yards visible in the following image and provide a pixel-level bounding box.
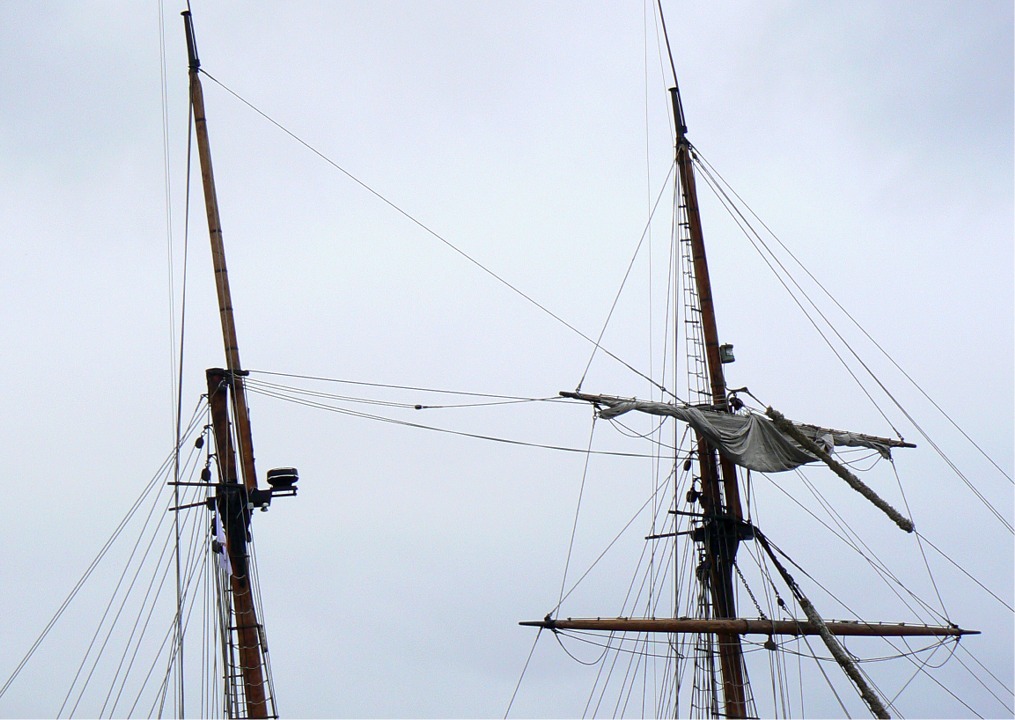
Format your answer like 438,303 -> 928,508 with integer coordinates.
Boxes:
670,85 -> 748,718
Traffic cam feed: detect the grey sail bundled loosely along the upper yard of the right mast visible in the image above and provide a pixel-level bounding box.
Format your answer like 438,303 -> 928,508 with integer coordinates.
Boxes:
560,393 -> 916,472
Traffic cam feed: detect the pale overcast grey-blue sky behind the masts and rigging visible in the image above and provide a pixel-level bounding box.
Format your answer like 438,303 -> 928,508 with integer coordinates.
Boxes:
0,1 -> 1015,717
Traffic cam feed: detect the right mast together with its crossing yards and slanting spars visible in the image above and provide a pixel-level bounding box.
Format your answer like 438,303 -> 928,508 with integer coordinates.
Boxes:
521,28 -> 978,718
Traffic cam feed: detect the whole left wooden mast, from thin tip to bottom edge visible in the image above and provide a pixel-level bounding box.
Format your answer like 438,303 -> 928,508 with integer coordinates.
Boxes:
183,11 -> 269,718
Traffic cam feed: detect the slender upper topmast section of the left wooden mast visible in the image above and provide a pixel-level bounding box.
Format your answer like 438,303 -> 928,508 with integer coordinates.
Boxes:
183,11 -> 257,492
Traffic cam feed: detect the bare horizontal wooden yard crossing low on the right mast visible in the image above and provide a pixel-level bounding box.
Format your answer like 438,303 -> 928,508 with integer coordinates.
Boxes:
519,617 -> 979,638
